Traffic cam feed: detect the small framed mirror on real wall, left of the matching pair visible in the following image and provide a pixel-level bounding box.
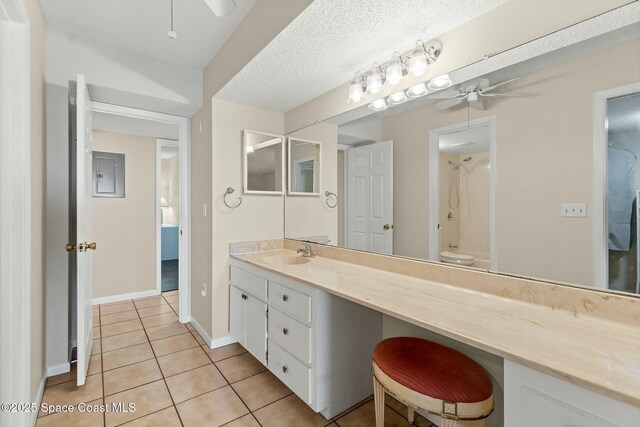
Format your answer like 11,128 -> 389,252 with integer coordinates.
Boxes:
242,130 -> 284,194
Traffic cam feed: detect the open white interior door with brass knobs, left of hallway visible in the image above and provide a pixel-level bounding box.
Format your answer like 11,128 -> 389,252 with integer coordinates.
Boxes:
71,74 -> 95,386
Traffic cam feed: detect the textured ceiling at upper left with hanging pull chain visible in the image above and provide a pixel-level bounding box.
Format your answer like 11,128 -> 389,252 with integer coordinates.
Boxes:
40,0 -> 256,69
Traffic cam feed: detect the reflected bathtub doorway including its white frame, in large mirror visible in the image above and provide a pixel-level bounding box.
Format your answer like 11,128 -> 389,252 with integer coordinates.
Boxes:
429,117 -> 497,270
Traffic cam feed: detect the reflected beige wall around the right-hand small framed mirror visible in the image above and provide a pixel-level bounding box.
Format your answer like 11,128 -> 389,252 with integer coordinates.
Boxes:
285,123 -> 342,244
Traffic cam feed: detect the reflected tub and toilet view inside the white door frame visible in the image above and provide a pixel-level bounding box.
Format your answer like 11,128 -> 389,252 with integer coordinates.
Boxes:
438,123 -> 492,269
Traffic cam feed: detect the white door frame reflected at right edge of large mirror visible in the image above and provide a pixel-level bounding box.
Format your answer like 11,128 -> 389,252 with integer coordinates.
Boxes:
591,83 -> 640,289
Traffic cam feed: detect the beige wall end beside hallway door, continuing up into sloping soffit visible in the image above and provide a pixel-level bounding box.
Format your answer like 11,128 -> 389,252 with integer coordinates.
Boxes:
191,0 -> 311,342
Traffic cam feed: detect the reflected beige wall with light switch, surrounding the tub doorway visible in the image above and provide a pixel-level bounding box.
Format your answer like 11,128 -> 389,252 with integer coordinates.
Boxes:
382,40 -> 640,285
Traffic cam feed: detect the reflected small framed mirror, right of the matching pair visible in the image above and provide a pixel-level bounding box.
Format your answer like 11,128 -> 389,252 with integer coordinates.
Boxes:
288,138 -> 321,196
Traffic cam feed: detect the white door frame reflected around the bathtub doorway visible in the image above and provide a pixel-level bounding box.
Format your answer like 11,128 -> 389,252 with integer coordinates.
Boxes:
427,116 -> 498,271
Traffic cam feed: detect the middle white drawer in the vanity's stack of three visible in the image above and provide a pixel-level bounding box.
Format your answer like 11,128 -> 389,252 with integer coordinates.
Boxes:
269,307 -> 312,365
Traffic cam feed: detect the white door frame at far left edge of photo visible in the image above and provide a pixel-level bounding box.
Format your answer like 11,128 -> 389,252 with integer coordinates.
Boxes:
0,0 -> 31,426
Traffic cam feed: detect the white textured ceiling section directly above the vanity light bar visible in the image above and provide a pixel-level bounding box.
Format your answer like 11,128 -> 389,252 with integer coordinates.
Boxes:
216,0 -> 506,112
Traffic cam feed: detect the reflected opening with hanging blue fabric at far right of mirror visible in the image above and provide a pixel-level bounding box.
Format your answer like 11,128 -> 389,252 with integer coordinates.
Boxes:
605,93 -> 640,293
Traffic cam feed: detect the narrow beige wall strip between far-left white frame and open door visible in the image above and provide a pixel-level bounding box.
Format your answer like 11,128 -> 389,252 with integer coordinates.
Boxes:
26,0 -> 45,402
